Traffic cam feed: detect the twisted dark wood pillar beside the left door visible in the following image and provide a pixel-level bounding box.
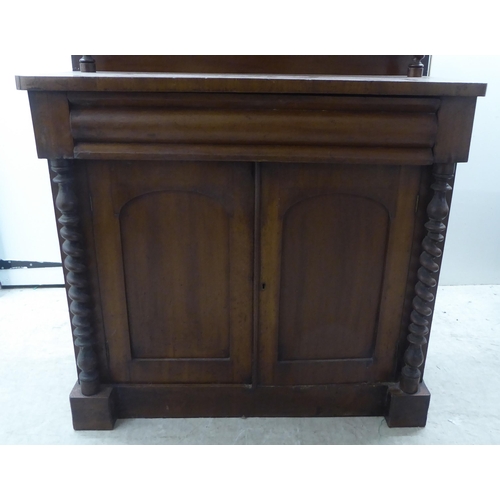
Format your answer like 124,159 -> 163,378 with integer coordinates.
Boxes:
49,160 -> 99,396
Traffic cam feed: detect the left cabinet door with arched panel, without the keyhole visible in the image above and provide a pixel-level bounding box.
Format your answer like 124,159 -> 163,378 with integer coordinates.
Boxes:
85,161 -> 254,383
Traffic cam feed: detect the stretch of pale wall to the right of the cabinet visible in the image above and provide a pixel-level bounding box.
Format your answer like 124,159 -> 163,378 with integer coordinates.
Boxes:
431,55 -> 500,285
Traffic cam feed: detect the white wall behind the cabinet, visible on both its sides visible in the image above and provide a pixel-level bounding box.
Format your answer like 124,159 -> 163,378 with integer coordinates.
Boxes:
0,53 -> 500,285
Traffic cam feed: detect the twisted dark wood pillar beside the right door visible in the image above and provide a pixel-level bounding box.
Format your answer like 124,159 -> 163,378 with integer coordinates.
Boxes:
399,164 -> 455,394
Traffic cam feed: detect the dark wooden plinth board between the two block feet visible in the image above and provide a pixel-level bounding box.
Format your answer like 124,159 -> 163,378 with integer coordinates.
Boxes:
115,384 -> 388,418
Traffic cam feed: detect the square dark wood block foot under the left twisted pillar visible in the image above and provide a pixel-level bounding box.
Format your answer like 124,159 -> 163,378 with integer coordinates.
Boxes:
69,382 -> 116,431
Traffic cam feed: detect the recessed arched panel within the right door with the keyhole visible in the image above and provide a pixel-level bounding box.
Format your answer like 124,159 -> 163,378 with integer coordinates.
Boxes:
278,194 -> 389,361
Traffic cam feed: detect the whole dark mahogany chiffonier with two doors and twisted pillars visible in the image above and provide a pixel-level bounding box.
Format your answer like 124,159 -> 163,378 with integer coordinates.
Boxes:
16,56 -> 486,429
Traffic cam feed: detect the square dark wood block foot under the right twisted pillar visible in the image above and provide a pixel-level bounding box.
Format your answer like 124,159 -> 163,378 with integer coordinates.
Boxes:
385,382 -> 431,427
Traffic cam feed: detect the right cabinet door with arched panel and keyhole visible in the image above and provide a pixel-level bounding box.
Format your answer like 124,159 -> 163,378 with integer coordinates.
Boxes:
259,163 -> 421,385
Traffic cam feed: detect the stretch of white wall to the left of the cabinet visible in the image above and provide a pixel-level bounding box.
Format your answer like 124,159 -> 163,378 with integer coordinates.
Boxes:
0,51 -> 71,285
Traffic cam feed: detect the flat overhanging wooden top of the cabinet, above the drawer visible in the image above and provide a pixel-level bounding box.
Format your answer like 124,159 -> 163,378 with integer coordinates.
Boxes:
16,71 -> 486,97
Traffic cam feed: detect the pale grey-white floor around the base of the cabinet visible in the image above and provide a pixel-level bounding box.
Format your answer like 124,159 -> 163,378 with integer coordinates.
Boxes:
0,285 -> 500,445
